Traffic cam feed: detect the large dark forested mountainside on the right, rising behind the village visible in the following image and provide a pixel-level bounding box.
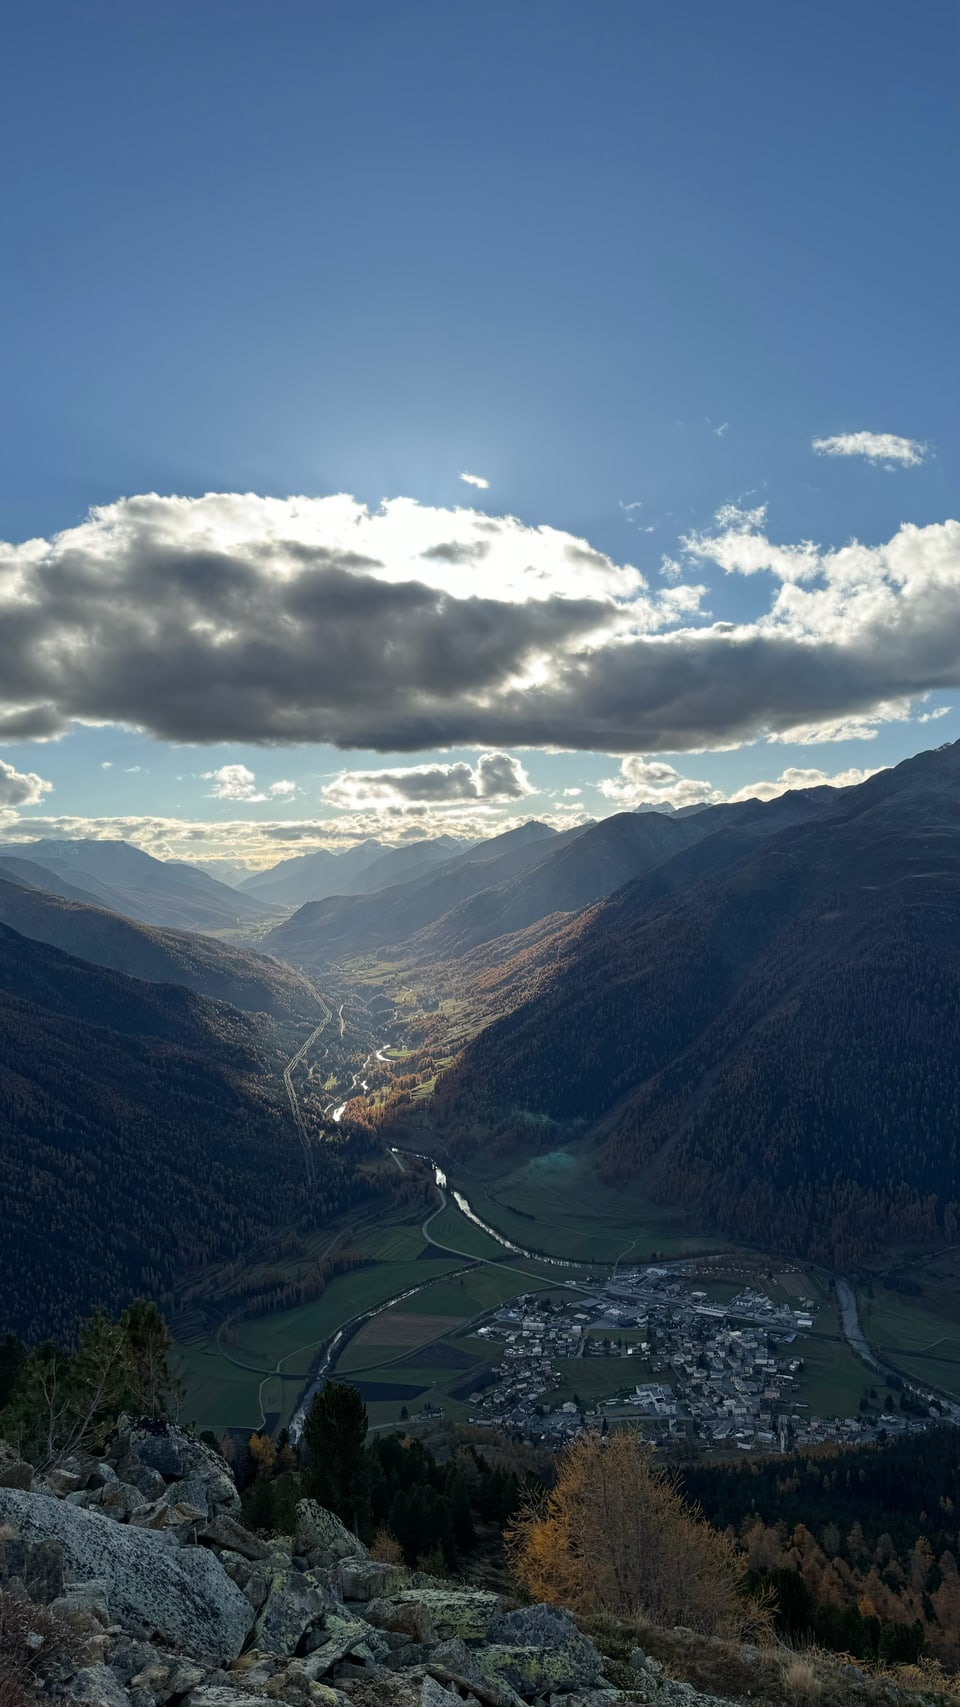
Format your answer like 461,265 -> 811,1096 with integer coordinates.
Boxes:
439,746 -> 960,1261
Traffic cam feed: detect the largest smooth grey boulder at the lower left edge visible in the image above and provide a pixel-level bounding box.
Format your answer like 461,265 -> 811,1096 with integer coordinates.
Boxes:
0,1489 -> 253,1659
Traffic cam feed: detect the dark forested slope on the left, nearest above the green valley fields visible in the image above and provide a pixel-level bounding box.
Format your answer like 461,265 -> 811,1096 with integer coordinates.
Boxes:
0,925 -> 351,1338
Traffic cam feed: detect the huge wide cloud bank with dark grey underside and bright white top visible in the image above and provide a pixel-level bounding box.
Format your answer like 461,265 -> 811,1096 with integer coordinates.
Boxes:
0,493 -> 960,761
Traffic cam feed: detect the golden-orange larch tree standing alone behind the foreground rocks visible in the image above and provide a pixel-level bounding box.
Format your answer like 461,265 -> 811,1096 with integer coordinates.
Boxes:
507,1429 -> 765,1635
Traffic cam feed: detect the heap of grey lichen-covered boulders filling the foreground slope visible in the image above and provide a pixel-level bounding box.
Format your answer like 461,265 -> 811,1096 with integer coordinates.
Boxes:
0,1420 -> 731,1707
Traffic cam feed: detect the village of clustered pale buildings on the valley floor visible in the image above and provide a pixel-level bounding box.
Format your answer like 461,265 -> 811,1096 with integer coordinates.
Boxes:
470,1267 -> 960,1453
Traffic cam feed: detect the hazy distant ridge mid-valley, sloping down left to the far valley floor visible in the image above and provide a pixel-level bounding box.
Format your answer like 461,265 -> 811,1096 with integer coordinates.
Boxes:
263,823 -> 567,966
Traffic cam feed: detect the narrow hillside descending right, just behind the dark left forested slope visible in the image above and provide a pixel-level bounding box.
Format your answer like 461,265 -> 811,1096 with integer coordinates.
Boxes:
0,860 -> 319,1017
